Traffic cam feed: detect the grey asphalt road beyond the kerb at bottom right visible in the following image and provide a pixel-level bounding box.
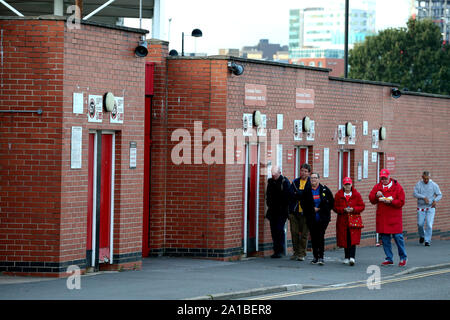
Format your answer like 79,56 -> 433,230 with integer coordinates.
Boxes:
251,269 -> 450,300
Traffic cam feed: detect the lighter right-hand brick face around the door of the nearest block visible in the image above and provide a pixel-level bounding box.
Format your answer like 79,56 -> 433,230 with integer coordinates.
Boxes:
60,21 -> 145,267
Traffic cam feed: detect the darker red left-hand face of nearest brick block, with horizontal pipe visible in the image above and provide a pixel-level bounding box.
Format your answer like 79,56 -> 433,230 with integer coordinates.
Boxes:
0,20 -> 64,276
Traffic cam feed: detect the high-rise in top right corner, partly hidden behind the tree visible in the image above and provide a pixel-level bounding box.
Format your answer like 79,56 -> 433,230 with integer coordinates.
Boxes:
411,0 -> 450,42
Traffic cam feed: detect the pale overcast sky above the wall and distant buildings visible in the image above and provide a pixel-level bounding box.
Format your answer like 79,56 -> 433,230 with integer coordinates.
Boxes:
126,0 -> 411,55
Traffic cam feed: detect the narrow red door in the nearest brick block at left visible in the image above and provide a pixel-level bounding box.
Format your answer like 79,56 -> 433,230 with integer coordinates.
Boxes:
99,134 -> 113,262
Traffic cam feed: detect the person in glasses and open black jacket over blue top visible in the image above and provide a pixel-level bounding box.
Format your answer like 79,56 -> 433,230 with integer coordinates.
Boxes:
305,172 -> 334,265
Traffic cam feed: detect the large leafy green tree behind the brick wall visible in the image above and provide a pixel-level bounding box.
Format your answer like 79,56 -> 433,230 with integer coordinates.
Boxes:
349,18 -> 450,95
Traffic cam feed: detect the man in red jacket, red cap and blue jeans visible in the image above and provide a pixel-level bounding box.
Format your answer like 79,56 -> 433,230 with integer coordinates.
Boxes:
369,169 -> 407,267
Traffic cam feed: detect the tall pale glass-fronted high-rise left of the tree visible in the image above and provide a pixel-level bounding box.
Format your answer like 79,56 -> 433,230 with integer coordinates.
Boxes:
289,0 -> 376,75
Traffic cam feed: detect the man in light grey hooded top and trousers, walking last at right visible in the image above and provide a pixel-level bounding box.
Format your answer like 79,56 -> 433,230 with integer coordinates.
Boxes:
413,171 -> 442,247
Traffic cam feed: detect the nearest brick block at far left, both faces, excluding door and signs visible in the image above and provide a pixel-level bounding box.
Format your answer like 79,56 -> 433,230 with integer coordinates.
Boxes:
0,20 -> 145,275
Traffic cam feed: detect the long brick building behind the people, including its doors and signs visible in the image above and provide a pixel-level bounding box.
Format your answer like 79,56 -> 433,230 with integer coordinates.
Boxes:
149,43 -> 450,259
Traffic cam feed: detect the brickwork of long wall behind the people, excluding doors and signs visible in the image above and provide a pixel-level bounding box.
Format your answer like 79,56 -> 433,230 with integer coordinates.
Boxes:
154,58 -> 450,259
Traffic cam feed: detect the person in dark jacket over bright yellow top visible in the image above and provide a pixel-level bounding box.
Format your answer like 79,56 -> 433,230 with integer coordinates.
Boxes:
289,163 -> 314,261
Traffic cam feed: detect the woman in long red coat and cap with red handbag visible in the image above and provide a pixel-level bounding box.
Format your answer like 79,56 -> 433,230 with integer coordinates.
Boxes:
333,177 -> 366,266
